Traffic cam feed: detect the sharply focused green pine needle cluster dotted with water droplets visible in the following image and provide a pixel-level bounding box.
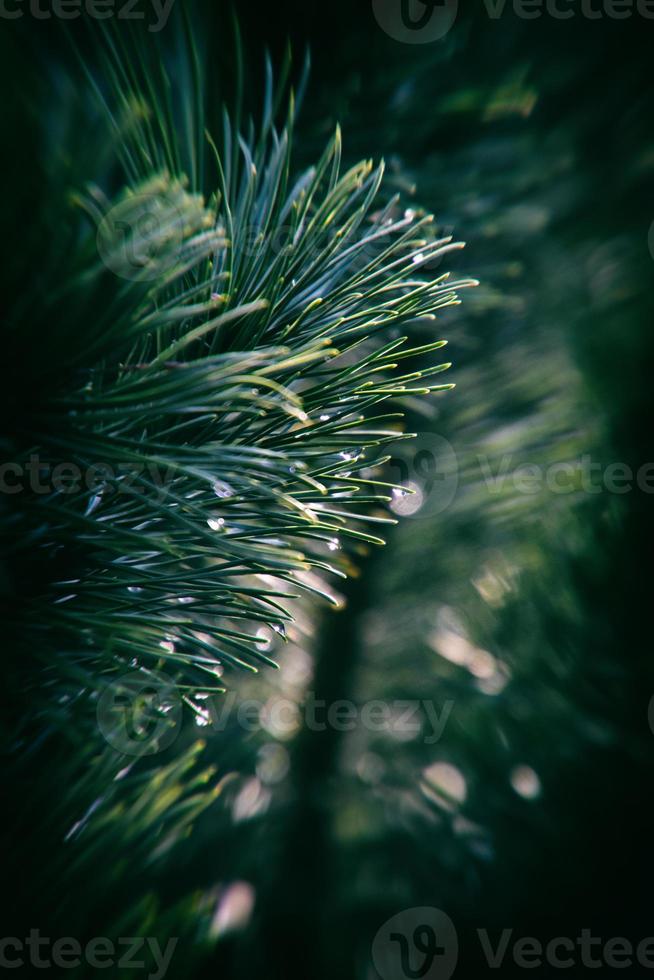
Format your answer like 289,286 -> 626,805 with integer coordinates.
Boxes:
2,23 -> 474,728
